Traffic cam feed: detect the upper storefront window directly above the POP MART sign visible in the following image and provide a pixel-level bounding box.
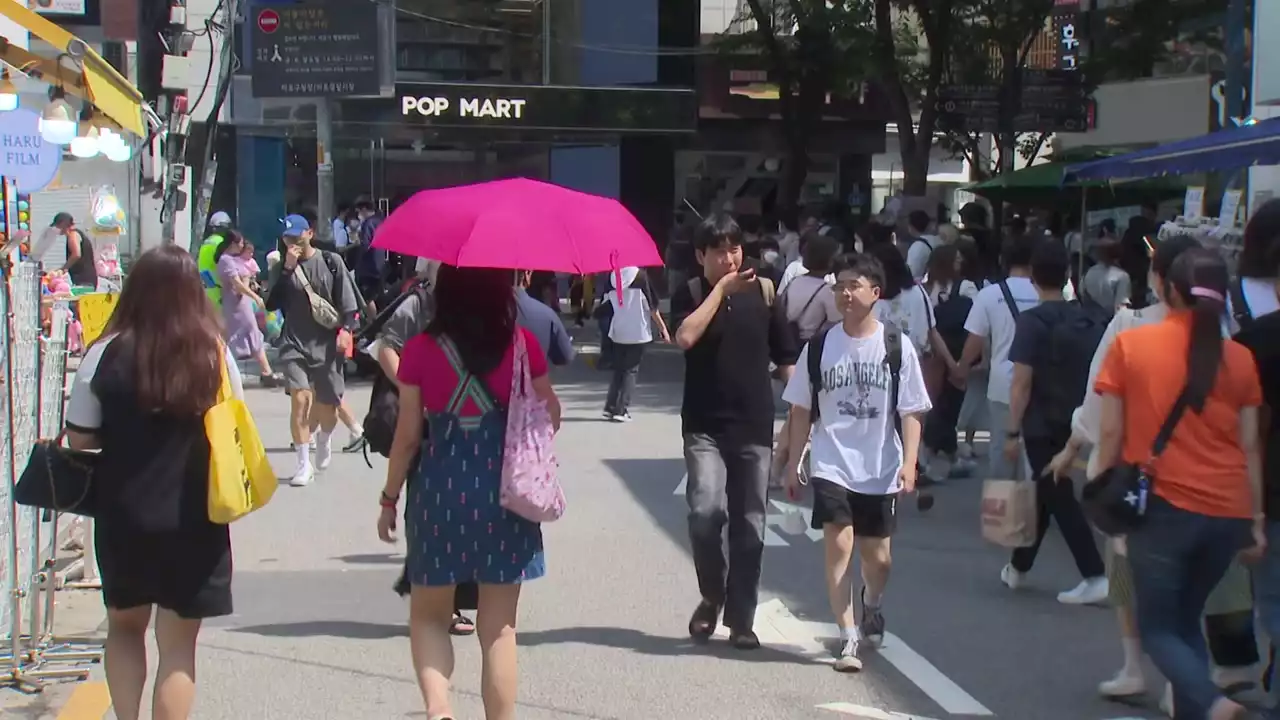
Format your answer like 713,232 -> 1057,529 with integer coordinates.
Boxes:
396,0 -> 549,85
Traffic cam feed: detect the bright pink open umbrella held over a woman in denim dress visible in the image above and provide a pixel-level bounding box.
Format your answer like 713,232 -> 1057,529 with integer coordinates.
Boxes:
372,178 -> 662,274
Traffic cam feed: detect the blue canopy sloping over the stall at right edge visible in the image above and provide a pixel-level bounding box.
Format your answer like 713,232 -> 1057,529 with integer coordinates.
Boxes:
1065,118 -> 1280,182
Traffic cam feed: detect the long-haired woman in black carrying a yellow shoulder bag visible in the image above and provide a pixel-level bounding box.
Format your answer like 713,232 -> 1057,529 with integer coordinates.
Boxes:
67,245 -> 242,720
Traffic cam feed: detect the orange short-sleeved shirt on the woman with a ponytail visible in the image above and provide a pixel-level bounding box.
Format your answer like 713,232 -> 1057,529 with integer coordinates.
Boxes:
1093,311 -> 1262,518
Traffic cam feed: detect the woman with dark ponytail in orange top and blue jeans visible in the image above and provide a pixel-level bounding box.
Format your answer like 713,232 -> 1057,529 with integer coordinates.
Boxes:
1094,247 -> 1266,720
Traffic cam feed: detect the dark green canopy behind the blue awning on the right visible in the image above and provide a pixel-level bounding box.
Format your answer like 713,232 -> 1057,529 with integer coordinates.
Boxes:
965,163 -> 1185,210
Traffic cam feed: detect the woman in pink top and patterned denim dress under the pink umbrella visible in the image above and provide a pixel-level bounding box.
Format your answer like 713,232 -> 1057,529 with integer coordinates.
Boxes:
378,265 -> 561,720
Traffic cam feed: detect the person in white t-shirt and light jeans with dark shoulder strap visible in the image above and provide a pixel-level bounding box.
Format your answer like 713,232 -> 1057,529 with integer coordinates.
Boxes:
956,233 -> 1056,478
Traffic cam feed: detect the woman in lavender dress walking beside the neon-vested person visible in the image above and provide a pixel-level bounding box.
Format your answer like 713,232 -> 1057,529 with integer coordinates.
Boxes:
214,229 -> 284,387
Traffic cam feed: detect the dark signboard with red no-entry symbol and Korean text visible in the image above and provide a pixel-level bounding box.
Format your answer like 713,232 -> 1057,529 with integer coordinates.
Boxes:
247,0 -> 381,97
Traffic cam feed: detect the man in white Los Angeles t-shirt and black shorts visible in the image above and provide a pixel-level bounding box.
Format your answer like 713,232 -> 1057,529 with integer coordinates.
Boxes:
782,255 -> 931,673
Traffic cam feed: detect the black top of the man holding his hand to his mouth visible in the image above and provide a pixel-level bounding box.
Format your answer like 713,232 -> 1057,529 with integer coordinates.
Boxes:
671,277 -> 800,445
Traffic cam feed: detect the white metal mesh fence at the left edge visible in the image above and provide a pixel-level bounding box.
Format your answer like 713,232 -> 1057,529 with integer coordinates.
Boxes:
0,263 -> 101,689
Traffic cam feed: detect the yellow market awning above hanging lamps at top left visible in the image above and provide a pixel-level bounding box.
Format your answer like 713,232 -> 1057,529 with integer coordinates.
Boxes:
0,0 -> 147,137
